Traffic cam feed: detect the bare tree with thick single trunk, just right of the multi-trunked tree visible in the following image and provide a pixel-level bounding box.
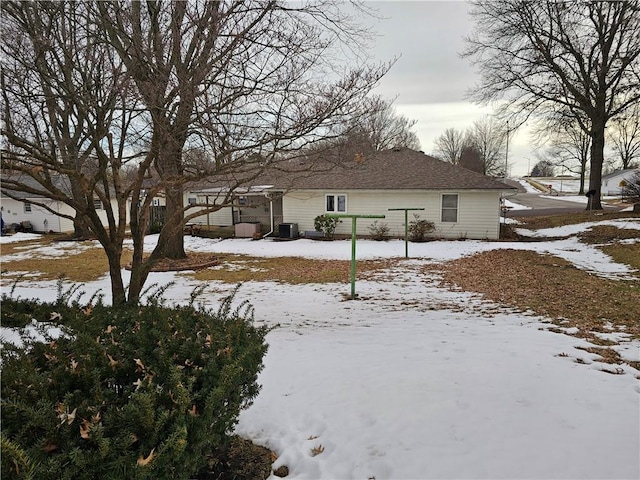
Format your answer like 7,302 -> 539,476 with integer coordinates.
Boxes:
97,0 -> 388,258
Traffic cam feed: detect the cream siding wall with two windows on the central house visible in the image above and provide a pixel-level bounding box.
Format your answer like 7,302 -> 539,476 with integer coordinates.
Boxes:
283,190 -> 500,240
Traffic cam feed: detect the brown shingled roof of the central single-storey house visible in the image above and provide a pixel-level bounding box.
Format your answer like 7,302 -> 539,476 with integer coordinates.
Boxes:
273,149 -> 513,190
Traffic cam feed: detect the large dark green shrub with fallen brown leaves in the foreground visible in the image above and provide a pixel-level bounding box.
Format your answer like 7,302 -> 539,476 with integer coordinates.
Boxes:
2,288 -> 267,480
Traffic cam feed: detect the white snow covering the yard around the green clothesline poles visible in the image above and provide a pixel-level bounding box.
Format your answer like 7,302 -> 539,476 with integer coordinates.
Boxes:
2,222 -> 640,480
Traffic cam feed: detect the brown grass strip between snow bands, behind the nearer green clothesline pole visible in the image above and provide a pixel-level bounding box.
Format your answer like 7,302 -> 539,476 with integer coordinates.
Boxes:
187,254 -> 393,284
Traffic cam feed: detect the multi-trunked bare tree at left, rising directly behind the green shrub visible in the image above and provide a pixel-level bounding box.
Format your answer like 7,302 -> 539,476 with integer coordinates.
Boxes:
0,1 -> 154,305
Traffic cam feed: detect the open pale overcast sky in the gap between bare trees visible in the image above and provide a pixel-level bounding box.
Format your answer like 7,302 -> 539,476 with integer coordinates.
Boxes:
360,0 -> 537,175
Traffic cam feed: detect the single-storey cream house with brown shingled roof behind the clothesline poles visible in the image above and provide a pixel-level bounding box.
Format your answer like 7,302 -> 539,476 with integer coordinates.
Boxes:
187,149 -> 514,240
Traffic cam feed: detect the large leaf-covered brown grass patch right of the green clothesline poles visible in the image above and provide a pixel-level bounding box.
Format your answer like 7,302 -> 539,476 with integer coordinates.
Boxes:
442,250 -> 640,338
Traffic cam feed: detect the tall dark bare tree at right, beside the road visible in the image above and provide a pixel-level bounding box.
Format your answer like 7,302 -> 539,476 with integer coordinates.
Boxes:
463,0 -> 640,209
